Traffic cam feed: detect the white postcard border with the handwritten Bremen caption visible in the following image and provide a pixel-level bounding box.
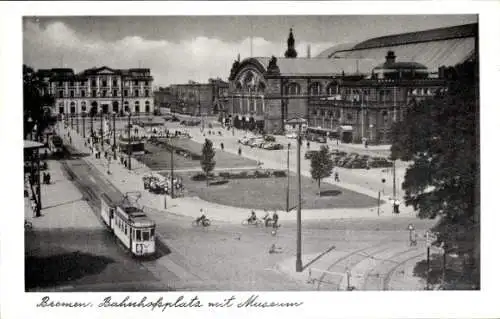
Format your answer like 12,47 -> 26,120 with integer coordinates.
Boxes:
0,1 -> 500,319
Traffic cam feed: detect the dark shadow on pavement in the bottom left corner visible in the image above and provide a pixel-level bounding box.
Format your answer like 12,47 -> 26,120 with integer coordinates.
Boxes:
24,251 -> 114,290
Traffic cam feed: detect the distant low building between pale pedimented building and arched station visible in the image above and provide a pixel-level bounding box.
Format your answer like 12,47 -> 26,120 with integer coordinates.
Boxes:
166,79 -> 229,115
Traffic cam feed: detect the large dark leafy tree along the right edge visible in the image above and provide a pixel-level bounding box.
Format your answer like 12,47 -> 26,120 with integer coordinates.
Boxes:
391,62 -> 480,287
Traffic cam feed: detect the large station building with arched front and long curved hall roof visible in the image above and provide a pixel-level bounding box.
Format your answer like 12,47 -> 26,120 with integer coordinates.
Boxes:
224,24 -> 478,143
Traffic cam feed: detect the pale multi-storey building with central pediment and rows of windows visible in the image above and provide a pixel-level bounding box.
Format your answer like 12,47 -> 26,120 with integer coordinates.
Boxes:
39,66 -> 154,115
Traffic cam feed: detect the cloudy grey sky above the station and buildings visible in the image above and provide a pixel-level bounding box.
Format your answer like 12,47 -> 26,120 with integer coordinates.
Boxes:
23,15 -> 478,86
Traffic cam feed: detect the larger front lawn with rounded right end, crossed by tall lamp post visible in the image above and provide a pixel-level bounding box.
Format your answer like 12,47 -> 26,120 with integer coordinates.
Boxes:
174,170 -> 377,210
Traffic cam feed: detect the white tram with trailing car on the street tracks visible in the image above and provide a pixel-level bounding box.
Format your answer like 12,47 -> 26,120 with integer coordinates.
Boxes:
101,194 -> 155,257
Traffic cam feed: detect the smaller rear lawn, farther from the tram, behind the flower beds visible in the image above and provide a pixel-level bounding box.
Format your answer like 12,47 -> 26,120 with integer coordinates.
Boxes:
144,139 -> 257,170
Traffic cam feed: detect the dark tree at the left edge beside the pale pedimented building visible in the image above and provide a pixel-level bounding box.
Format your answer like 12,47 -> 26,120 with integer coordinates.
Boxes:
23,64 -> 54,140
